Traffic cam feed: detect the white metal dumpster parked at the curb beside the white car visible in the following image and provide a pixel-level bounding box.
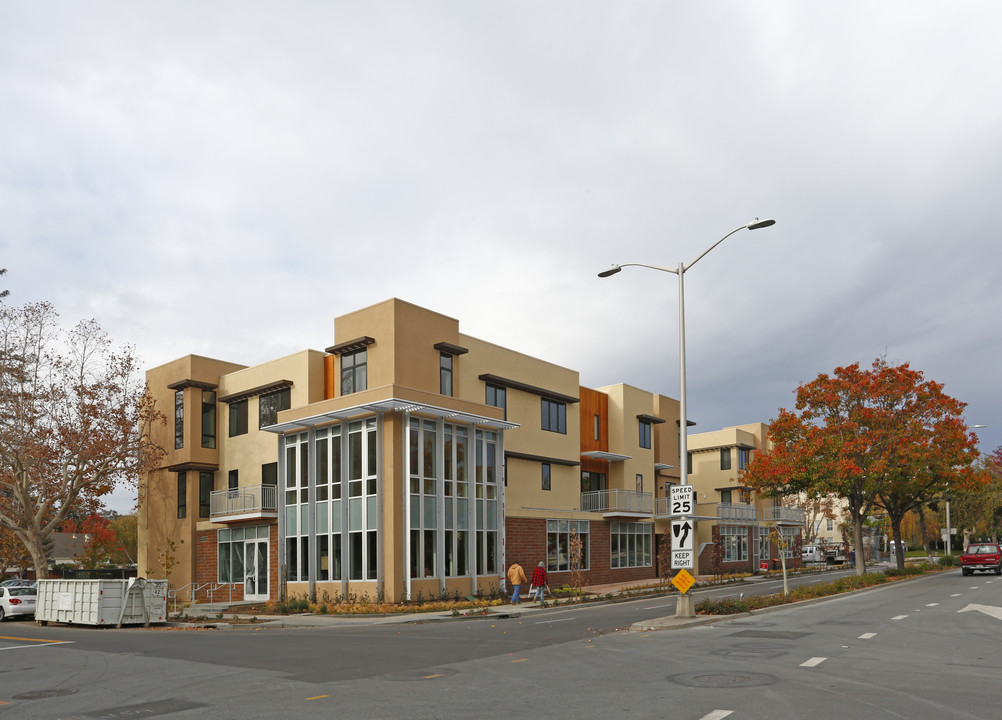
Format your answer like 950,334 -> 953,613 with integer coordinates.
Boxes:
35,578 -> 167,626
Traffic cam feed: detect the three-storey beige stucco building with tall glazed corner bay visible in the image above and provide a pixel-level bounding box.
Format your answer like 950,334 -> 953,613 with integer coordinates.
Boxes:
138,299 -> 801,601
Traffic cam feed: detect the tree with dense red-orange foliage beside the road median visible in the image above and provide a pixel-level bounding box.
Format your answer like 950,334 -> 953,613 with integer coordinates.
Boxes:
740,358 -> 981,575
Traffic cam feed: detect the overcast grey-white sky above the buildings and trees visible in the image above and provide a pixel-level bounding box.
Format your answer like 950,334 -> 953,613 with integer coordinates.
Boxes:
0,0 -> 1002,516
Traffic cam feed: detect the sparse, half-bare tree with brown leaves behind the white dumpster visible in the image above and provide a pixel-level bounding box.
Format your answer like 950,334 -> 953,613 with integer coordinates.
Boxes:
0,302 -> 163,579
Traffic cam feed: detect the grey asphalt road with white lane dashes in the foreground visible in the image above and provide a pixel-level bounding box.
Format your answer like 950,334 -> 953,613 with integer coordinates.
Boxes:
0,571 -> 1002,720
